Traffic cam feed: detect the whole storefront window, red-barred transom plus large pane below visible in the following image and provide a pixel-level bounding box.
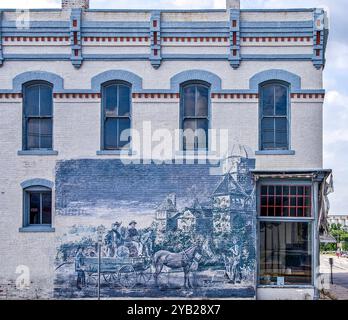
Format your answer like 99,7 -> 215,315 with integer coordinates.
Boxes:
259,183 -> 313,286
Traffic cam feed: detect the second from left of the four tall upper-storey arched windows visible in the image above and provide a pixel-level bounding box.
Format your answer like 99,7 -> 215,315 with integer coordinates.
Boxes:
102,82 -> 131,150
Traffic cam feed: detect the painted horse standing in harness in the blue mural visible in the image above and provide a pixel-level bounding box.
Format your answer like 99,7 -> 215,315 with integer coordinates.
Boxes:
153,240 -> 213,289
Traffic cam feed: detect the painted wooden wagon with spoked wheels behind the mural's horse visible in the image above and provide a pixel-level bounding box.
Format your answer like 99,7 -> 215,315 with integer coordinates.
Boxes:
84,257 -> 152,289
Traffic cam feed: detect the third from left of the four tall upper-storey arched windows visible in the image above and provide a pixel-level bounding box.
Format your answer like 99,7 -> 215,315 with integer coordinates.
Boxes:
181,83 -> 210,151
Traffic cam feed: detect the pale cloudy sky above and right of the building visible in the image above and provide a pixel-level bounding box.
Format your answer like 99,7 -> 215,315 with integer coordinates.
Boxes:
0,0 -> 348,214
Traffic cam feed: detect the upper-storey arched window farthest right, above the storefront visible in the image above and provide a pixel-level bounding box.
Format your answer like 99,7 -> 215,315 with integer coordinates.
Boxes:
260,82 -> 290,150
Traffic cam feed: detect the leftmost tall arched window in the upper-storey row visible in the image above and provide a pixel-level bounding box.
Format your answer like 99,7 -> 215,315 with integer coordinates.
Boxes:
23,82 -> 53,150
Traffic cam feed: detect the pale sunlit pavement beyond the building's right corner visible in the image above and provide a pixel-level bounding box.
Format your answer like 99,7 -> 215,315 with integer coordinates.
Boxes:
320,255 -> 348,300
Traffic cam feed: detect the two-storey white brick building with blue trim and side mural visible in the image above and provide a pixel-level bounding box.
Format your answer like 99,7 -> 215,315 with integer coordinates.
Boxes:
0,0 -> 332,299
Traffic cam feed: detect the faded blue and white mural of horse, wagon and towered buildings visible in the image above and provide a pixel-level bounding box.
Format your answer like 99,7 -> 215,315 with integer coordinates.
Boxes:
55,156 -> 256,298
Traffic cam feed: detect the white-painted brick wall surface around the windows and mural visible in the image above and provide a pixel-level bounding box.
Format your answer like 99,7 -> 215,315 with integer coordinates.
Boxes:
0,8 -> 322,297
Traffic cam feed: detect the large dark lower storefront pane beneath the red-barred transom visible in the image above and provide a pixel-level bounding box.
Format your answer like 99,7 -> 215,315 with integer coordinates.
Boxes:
259,221 -> 312,286
